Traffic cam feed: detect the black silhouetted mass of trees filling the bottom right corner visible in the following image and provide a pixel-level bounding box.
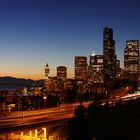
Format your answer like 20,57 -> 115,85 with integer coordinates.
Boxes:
68,98 -> 140,140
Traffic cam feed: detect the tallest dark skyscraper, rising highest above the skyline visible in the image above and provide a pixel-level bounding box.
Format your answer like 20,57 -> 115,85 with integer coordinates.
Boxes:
103,27 -> 117,86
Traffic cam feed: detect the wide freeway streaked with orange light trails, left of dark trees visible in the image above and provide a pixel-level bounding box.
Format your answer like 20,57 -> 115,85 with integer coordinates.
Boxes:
0,102 -> 90,129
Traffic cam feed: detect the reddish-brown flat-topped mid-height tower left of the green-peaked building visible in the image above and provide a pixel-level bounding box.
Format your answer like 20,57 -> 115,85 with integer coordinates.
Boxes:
75,56 -> 87,81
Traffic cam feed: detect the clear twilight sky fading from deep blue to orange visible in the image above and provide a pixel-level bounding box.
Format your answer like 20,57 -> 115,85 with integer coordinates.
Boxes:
0,0 -> 140,79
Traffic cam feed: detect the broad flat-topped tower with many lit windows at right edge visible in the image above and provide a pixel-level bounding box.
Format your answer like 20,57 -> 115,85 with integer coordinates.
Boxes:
124,40 -> 139,82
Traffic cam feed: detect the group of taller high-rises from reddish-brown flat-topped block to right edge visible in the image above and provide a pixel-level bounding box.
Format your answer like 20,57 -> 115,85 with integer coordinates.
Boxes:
75,27 -> 139,86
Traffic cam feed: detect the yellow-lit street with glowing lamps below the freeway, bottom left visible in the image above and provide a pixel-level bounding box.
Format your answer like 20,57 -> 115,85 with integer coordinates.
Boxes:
0,120 -> 67,140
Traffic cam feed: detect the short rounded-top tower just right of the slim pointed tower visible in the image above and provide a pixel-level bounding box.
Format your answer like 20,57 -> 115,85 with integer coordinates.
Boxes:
57,66 -> 67,81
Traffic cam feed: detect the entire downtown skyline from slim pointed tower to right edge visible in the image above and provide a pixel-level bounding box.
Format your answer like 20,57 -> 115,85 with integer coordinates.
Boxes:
45,27 -> 139,92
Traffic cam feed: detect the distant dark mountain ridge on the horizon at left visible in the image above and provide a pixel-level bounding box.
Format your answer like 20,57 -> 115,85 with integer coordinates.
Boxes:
0,76 -> 43,87
